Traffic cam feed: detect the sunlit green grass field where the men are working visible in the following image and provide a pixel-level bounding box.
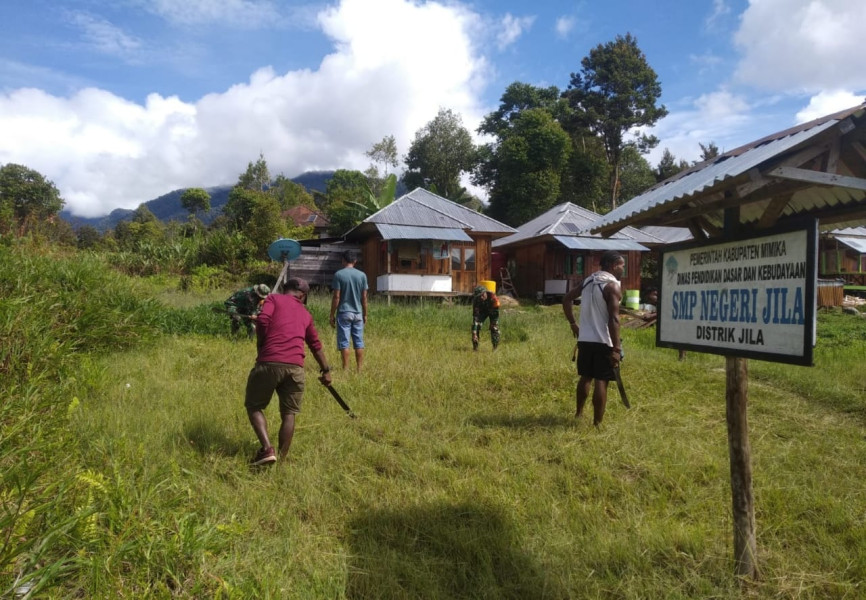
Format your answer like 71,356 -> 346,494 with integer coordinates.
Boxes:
0,248 -> 866,599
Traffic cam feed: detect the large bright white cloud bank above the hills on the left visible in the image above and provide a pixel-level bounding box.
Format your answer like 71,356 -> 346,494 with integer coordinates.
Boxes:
0,0 -> 489,216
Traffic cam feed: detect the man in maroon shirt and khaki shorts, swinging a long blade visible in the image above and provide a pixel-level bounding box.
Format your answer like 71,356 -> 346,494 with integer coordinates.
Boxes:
244,278 -> 331,465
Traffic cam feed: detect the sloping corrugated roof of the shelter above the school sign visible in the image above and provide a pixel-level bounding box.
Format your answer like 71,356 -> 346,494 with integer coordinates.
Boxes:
593,104 -> 866,233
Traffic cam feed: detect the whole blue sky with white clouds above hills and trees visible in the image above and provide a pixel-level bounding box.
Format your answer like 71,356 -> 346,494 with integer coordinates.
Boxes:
0,0 -> 866,216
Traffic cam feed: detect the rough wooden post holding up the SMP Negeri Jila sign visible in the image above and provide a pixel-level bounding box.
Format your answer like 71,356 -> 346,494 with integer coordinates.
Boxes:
725,356 -> 759,579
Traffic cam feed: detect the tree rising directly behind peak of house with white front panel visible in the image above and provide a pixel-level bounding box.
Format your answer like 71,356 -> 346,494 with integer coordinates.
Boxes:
403,109 -> 477,200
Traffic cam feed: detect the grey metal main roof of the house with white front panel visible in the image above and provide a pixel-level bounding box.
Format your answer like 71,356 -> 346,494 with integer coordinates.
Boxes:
364,188 -> 515,235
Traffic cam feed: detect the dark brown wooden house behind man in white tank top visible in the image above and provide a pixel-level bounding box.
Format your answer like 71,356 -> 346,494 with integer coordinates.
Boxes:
493,202 -> 664,299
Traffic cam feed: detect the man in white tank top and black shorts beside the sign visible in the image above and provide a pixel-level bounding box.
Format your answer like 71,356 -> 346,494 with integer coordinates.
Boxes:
562,251 -> 625,426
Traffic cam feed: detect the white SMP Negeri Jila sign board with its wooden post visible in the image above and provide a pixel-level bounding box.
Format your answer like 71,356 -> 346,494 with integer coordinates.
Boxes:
656,220 -> 818,578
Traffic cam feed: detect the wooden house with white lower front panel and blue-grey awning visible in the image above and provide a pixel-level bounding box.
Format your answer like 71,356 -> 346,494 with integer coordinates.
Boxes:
345,188 -> 515,296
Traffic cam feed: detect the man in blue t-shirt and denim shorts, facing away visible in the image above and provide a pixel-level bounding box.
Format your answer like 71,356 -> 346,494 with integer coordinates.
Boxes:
330,250 -> 367,373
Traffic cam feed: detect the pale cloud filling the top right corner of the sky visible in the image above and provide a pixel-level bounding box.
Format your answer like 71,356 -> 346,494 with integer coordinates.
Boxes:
735,0 -> 866,94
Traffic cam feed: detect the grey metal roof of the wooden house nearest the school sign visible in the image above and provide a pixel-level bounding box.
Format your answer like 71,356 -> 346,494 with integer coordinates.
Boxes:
493,202 -> 664,250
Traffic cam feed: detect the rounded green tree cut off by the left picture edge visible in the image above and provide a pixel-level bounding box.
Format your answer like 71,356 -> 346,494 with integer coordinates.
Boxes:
0,163 -> 64,235
